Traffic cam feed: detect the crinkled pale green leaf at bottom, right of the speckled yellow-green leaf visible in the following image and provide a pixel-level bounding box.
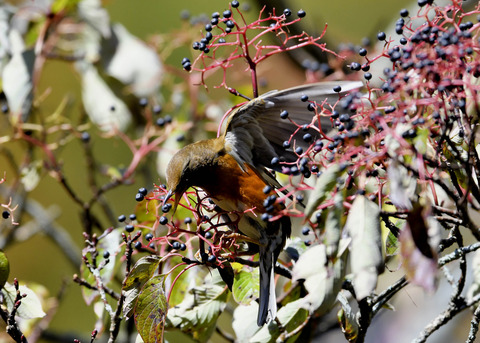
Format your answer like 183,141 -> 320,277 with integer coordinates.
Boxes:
166,270 -> 228,342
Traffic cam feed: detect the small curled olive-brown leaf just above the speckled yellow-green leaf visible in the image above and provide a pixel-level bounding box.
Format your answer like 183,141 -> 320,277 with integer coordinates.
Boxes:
123,256 -> 160,317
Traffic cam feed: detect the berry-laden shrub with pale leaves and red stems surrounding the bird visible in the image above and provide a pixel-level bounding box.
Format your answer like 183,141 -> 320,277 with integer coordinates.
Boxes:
0,0 -> 480,342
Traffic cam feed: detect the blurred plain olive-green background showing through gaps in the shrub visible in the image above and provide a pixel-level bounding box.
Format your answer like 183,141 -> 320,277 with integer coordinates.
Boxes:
0,0 -> 406,339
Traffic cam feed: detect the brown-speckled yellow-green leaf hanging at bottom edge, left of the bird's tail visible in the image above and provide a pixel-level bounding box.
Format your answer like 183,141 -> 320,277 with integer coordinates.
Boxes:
134,275 -> 168,343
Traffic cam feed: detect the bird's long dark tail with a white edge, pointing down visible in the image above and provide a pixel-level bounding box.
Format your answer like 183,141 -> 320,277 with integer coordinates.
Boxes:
257,246 -> 277,326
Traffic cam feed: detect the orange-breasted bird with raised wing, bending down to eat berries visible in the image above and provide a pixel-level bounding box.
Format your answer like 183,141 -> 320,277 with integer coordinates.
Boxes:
165,81 -> 362,326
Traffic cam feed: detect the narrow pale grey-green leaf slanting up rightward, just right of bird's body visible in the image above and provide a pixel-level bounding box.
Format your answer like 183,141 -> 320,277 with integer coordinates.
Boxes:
305,163 -> 345,218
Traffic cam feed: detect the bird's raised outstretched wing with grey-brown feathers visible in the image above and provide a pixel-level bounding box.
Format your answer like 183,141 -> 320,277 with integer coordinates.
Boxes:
224,81 -> 363,174
